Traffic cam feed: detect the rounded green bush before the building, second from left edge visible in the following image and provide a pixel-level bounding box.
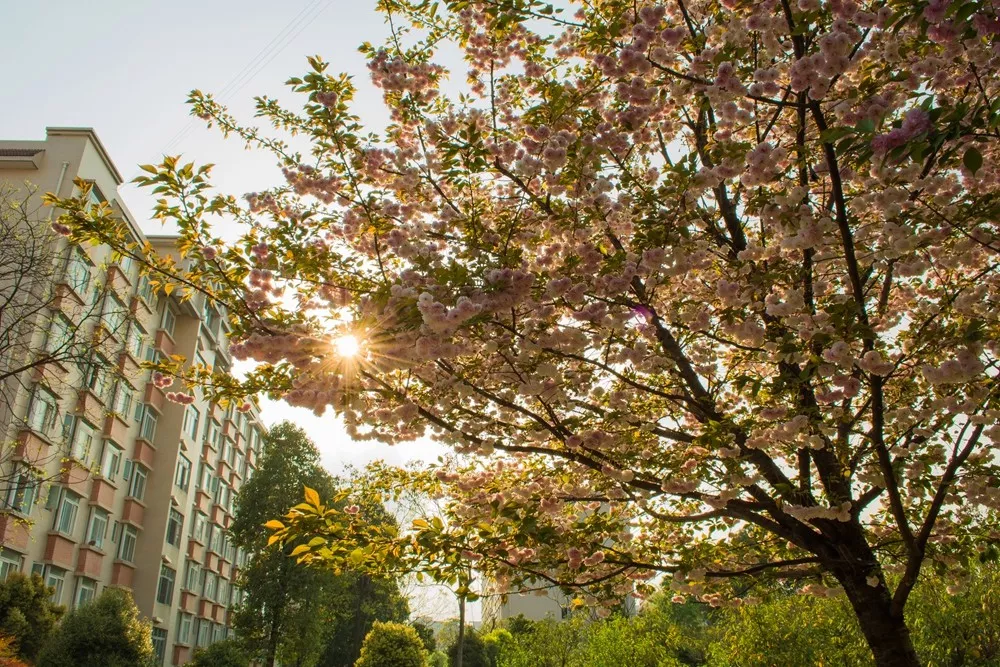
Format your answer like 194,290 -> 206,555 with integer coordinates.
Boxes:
37,588 -> 153,667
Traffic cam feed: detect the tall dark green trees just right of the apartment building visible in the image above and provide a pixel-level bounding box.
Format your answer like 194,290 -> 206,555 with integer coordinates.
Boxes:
230,422 -> 409,667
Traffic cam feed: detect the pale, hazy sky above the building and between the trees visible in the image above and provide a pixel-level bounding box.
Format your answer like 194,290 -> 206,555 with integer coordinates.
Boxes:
0,0 -> 475,617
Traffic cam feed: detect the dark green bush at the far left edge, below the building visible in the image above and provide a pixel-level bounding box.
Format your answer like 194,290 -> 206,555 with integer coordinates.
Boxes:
0,573 -> 65,661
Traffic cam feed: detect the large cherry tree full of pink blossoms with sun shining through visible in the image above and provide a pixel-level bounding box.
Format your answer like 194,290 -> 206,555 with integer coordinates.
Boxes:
50,0 -> 1000,666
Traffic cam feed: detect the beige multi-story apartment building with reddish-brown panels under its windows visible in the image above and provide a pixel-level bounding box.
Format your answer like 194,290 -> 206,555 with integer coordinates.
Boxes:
0,128 -> 262,665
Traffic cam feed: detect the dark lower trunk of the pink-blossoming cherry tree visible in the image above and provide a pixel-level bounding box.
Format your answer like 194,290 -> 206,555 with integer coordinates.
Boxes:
838,573 -> 920,667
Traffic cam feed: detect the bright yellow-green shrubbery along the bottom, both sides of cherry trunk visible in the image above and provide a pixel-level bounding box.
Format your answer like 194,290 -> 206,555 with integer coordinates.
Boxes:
487,565 -> 1000,667
